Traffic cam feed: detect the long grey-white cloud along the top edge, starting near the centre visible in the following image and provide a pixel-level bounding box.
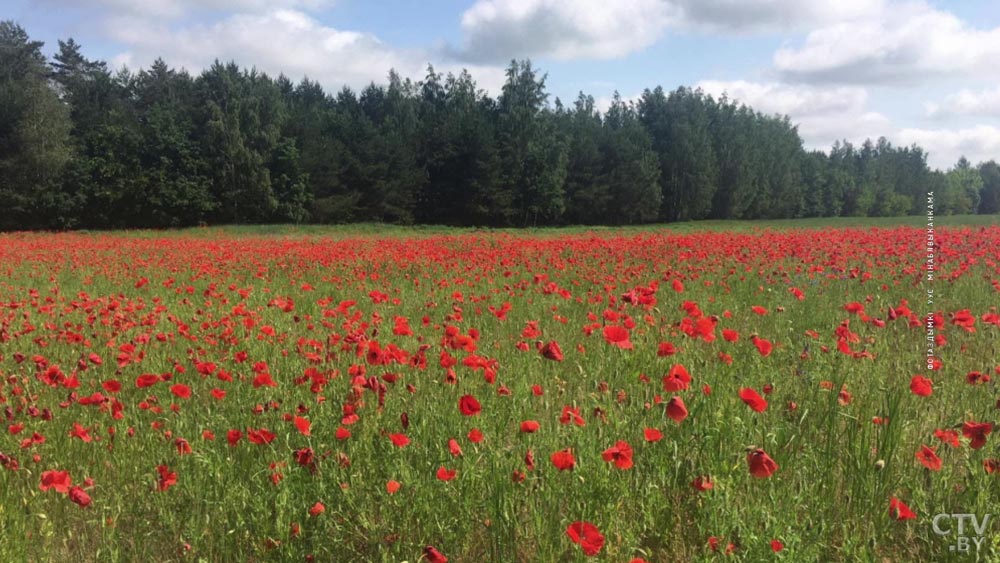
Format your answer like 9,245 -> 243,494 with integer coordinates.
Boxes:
456,0 -> 885,62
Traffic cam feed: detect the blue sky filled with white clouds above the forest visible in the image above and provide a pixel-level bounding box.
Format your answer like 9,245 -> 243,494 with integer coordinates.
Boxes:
7,0 -> 1000,170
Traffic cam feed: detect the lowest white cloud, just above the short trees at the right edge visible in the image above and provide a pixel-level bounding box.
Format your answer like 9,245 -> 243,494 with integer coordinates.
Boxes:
896,125 -> 1000,170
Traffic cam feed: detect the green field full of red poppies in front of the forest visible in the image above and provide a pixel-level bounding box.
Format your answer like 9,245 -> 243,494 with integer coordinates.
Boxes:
0,225 -> 1000,563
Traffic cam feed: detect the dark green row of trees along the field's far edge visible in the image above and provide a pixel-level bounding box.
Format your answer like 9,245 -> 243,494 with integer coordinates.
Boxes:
0,21 -> 1000,230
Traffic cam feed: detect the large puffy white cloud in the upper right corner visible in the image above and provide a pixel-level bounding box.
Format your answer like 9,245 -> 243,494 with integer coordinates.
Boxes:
774,1 -> 1000,84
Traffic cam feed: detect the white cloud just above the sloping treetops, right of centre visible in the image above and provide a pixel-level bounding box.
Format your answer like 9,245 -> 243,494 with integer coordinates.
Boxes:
696,80 -> 889,150
